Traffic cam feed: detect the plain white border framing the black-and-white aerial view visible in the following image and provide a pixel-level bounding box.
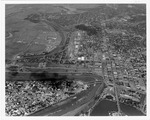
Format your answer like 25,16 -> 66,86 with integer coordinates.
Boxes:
0,0 -> 150,120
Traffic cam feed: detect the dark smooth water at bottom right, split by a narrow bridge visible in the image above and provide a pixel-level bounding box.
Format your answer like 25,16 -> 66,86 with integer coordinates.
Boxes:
91,100 -> 144,116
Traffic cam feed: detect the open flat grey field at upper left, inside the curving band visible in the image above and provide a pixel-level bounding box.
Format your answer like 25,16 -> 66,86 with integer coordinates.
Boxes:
5,5 -> 61,60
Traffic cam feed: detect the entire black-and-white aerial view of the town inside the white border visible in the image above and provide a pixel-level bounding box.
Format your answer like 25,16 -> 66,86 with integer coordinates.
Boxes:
5,3 -> 147,116
